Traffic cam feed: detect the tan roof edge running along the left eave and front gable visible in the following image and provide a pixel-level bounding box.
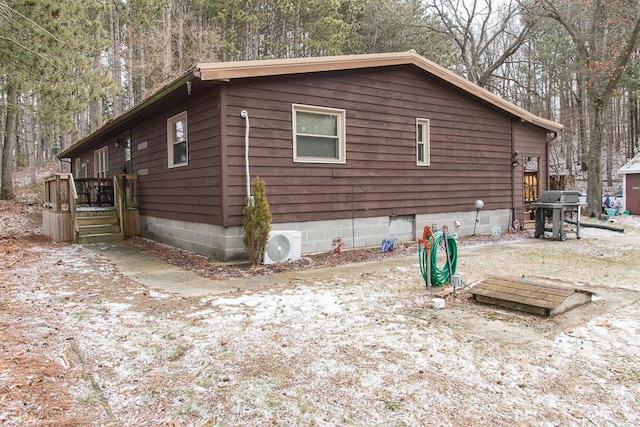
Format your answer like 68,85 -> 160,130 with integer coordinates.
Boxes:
58,50 -> 564,158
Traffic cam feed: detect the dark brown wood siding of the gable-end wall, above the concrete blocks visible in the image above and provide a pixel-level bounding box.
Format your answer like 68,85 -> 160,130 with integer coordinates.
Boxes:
221,66 -> 544,225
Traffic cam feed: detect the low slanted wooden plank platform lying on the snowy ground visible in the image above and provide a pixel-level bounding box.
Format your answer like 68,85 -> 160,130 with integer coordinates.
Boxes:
471,277 -> 593,316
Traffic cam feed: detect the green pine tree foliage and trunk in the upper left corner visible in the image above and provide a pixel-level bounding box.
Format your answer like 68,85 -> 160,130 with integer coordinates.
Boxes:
0,0 -> 113,199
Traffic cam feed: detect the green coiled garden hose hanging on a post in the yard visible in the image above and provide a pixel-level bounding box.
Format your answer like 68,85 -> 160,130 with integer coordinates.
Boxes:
418,231 -> 458,286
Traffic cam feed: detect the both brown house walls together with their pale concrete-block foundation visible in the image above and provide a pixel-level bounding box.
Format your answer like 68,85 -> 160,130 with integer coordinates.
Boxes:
62,65 -> 547,259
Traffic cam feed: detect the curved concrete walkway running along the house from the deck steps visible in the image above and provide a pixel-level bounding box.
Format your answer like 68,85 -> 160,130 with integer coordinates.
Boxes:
83,242 -> 418,297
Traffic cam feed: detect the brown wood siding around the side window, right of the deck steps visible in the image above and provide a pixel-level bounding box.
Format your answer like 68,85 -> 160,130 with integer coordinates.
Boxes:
132,89 -> 222,225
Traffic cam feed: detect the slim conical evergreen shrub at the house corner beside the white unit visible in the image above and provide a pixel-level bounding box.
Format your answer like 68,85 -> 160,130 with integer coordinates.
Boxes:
242,176 -> 271,266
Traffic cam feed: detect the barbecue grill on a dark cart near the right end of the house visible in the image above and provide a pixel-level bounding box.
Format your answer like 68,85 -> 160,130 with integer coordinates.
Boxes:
531,190 -> 586,241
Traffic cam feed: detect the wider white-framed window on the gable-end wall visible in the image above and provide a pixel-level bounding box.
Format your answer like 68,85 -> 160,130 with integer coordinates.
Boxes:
293,104 -> 346,163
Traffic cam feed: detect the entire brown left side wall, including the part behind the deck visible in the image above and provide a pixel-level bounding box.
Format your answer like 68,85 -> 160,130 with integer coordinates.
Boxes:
71,87 -> 228,235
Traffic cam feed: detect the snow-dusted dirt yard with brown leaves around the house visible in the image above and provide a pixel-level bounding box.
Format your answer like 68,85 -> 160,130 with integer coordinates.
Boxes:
0,176 -> 640,426
